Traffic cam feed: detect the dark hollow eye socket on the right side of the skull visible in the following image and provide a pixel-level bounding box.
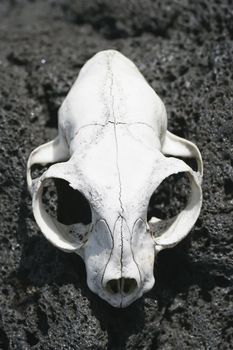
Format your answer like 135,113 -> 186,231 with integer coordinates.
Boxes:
147,173 -> 190,221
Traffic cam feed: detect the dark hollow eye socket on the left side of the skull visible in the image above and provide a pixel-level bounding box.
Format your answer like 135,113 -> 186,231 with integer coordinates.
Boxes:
42,179 -> 92,225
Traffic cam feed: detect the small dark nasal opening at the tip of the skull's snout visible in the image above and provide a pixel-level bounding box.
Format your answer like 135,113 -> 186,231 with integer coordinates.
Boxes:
106,277 -> 137,295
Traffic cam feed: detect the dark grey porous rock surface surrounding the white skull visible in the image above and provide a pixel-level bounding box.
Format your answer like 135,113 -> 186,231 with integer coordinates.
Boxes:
0,0 -> 233,350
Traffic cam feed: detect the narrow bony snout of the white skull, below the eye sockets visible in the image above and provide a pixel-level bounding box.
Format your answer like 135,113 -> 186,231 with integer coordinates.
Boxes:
84,217 -> 155,308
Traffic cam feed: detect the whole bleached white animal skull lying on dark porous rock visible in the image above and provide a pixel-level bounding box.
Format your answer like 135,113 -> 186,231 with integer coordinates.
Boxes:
27,50 -> 202,307
